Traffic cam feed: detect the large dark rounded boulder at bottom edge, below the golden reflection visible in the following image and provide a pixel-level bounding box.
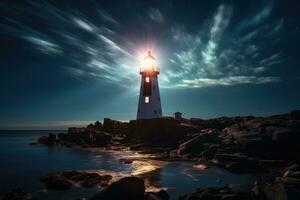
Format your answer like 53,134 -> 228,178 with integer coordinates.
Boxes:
89,177 -> 145,200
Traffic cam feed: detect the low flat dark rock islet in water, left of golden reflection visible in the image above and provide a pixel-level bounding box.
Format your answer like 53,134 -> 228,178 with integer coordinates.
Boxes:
40,171 -> 112,190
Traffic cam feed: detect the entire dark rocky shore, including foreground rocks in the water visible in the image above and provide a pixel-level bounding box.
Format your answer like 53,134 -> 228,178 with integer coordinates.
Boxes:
4,111 -> 300,200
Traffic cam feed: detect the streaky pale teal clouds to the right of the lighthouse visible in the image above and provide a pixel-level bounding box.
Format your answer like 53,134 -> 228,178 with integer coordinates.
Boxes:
162,4 -> 283,88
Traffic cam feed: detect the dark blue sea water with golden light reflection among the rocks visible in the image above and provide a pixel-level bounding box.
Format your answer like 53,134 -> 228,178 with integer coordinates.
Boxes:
0,131 -> 257,200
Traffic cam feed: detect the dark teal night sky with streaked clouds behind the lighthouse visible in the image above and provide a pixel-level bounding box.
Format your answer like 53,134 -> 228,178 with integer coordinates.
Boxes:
0,0 -> 300,129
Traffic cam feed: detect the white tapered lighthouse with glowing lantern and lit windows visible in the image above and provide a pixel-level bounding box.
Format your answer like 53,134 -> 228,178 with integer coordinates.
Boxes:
137,51 -> 162,119
